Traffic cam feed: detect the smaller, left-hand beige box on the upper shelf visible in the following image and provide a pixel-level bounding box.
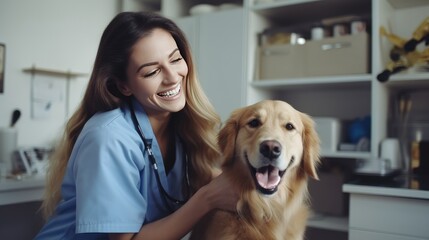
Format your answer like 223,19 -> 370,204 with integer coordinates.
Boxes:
259,44 -> 306,79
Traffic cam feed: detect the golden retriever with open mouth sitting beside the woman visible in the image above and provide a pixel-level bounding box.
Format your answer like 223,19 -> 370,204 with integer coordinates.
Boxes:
191,100 -> 320,240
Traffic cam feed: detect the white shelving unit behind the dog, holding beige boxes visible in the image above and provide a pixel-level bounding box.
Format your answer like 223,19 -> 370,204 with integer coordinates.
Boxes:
245,0 -> 429,237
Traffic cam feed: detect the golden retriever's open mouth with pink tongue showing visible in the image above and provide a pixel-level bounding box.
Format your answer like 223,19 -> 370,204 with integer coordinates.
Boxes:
246,156 -> 285,195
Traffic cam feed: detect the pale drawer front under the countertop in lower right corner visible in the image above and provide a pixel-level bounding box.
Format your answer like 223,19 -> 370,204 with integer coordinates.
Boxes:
349,194 -> 429,239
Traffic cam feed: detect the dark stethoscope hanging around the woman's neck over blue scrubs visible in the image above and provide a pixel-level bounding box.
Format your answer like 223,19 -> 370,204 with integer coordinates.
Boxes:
128,100 -> 190,211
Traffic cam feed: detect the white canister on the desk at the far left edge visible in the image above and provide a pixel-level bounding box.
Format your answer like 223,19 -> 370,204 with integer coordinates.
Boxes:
0,127 -> 18,177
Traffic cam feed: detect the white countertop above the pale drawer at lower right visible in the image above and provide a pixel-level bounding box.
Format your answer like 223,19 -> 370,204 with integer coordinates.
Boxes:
343,175 -> 429,200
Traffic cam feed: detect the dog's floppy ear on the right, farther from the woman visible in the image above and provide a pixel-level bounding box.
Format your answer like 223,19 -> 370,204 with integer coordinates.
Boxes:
301,113 -> 320,179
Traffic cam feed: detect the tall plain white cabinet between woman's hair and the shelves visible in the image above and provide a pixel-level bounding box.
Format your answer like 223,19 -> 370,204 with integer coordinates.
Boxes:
175,8 -> 246,120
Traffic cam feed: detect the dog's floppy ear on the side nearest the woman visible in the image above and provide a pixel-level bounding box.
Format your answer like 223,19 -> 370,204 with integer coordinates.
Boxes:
218,109 -> 241,164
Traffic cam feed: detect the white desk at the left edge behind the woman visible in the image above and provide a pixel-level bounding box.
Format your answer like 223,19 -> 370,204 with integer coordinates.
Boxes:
0,176 -> 45,205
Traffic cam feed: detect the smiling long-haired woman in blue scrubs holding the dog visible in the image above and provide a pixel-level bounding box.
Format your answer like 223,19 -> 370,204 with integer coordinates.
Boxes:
35,12 -> 238,240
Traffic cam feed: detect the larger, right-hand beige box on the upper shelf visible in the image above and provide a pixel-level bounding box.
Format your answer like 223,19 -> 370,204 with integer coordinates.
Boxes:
305,33 -> 370,76
